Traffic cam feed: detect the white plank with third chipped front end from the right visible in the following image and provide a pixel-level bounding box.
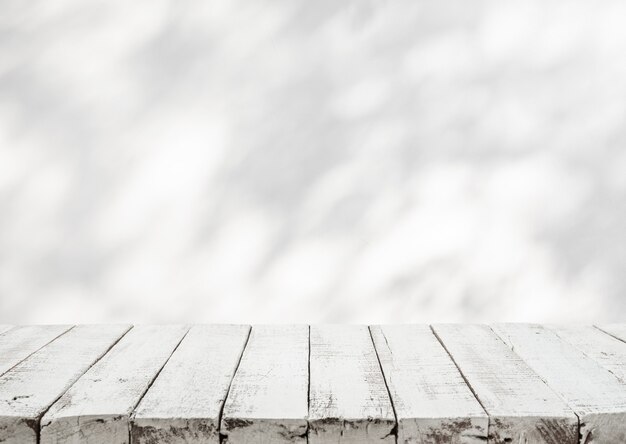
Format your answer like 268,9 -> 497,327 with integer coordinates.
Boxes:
370,325 -> 489,444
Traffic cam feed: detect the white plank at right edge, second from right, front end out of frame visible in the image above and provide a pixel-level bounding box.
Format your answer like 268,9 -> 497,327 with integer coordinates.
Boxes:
548,325 -> 626,382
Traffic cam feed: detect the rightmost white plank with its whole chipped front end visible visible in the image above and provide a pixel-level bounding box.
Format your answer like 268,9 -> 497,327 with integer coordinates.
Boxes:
433,324 -> 578,444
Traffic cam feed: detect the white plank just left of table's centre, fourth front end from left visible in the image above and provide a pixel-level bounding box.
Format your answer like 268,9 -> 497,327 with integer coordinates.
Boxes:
220,325 -> 309,444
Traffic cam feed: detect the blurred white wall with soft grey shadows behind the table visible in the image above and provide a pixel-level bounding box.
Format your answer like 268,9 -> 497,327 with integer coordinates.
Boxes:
0,0 -> 626,323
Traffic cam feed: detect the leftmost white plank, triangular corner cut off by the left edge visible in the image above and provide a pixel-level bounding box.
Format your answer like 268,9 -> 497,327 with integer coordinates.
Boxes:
0,325 -> 72,375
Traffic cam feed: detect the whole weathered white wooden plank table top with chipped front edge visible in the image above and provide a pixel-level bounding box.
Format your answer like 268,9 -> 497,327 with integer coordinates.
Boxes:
0,324 -> 626,444
